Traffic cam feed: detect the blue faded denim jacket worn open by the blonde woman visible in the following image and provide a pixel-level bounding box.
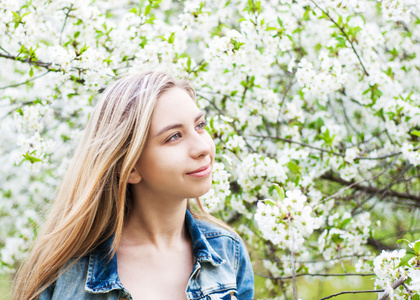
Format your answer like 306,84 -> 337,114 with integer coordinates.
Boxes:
39,211 -> 254,300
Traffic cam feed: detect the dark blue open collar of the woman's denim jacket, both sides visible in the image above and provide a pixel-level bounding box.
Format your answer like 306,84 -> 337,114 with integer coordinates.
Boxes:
85,210 -> 225,293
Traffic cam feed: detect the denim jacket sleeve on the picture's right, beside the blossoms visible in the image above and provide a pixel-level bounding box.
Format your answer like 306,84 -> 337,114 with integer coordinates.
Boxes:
236,240 -> 254,300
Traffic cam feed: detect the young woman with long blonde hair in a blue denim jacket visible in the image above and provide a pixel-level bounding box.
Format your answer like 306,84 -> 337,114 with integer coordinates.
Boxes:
13,72 -> 253,300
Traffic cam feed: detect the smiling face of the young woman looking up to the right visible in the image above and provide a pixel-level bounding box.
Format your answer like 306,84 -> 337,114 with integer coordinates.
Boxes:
136,88 -> 215,199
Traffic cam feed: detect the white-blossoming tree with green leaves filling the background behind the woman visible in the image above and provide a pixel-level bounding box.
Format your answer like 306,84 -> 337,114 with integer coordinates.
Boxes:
0,0 -> 420,299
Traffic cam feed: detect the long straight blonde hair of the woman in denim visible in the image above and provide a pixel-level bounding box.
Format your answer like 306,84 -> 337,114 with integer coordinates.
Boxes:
12,72 -> 226,300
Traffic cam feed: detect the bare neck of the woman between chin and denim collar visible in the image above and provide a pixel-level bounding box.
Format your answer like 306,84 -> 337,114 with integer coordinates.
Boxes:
121,187 -> 189,249
